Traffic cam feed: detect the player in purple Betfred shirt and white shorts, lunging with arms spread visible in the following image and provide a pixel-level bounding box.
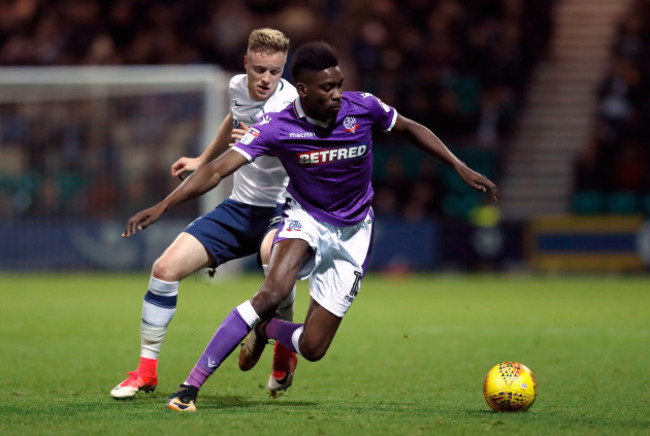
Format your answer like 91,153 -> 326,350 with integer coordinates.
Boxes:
124,42 -> 498,411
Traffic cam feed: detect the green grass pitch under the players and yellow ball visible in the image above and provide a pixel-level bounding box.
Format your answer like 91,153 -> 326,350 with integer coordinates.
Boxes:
0,273 -> 650,436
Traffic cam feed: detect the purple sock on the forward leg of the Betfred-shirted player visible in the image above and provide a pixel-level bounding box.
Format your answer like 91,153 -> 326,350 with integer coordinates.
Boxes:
186,309 -> 250,389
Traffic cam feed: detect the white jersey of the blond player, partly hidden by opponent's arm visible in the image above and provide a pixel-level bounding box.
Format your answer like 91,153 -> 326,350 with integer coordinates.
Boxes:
228,74 -> 298,207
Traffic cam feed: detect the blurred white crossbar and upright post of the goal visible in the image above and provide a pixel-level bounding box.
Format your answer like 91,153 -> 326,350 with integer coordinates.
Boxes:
0,66 -> 229,216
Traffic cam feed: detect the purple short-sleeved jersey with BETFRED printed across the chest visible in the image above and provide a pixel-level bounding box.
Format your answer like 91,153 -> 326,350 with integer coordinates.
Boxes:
233,92 -> 397,226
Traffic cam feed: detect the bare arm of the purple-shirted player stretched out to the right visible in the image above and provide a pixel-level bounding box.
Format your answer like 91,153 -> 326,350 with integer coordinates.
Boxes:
392,115 -> 499,201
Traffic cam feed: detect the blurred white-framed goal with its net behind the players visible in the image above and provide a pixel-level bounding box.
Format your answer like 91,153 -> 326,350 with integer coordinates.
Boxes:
0,66 -> 230,269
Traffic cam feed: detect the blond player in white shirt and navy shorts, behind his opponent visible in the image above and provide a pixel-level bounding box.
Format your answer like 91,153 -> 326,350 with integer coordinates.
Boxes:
111,28 -> 297,398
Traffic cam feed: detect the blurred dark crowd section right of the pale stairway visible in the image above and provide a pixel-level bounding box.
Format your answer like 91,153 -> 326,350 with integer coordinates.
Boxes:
574,0 -> 650,213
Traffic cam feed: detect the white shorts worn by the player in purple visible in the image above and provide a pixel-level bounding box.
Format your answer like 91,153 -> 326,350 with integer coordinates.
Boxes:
275,200 -> 374,318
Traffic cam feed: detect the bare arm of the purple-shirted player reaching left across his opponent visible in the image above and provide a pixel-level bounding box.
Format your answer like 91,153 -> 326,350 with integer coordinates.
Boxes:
122,150 -> 248,238
